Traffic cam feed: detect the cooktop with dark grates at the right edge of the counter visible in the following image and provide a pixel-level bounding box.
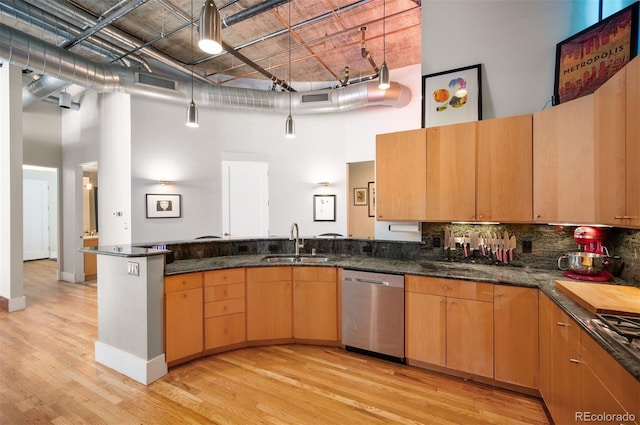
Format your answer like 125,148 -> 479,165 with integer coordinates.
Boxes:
591,314 -> 640,361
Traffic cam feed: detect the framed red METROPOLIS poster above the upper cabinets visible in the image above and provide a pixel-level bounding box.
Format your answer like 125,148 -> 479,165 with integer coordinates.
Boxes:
553,2 -> 638,105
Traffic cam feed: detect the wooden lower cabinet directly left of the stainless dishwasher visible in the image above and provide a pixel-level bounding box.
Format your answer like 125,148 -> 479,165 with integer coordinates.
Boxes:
293,267 -> 338,343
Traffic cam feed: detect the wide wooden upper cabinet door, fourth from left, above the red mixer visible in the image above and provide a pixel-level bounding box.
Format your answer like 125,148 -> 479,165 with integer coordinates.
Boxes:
533,96 -> 596,223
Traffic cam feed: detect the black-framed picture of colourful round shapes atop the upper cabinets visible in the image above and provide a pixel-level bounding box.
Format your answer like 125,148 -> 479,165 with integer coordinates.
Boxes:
422,64 -> 482,128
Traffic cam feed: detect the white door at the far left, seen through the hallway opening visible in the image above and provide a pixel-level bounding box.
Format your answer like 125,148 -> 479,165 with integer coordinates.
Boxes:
22,179 -> 50,261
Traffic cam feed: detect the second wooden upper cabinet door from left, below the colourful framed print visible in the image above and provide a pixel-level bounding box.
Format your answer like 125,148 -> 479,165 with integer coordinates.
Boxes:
424,121 -> 476,221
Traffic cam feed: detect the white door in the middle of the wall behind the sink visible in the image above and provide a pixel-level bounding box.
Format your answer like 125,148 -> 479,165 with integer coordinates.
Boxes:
222,161 -> 269,238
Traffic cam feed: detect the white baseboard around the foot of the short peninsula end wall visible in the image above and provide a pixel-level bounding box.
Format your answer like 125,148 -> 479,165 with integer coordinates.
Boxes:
95,341 -> 168,385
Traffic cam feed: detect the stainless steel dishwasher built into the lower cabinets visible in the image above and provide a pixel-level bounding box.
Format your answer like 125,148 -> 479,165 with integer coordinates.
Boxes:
342,270 -> 405,363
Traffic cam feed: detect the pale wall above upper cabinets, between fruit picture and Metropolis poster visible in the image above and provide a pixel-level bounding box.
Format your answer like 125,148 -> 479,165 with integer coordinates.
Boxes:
422,0 -> 597,119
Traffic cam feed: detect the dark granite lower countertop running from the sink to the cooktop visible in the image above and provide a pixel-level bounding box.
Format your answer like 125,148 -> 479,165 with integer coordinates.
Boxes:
165,255 -> 640,381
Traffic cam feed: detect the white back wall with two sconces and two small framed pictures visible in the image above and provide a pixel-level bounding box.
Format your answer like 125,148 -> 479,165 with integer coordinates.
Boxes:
127,65 -> 421,242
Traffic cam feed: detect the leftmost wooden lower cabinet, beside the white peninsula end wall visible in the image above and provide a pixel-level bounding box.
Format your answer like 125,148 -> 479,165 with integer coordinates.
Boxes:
164,272 -> 204,366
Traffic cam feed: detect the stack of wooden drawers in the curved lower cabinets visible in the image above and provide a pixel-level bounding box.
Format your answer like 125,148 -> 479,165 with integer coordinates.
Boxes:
204,268 -> 246,351
